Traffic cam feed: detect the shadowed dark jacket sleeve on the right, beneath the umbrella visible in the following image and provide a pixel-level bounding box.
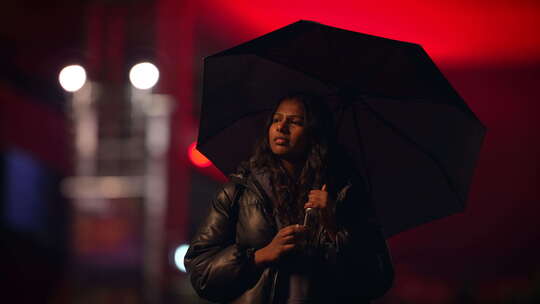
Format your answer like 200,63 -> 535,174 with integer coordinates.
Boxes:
317,179 -> 394,300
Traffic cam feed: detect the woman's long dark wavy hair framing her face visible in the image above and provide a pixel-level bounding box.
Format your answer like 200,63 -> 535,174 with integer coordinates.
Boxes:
249,93 -> 342,225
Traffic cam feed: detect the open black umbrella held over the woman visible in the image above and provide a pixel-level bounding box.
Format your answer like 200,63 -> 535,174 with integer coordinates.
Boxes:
197,21 -> 485,237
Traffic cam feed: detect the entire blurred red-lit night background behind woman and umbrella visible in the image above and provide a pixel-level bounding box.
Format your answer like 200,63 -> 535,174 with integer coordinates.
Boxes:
0,0 -> 540,304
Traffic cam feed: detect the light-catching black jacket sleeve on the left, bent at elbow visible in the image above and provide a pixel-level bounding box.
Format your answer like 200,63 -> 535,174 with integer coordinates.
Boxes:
184,183 -> 257,301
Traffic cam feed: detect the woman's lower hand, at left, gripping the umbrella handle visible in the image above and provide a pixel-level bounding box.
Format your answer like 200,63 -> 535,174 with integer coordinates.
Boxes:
255,225 -> 306,265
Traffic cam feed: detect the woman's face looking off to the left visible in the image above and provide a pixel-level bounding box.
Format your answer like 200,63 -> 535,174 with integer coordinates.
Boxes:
268,99 -> 307,160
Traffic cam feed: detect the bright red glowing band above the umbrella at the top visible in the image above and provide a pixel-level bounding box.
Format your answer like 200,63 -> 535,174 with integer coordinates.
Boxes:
201,0 -> 540,65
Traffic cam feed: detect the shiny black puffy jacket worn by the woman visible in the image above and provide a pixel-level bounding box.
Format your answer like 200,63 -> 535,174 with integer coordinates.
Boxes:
185,167 -> 394,304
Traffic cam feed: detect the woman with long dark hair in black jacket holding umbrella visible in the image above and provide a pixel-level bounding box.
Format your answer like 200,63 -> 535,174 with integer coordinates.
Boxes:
185,95 -> 393,304
